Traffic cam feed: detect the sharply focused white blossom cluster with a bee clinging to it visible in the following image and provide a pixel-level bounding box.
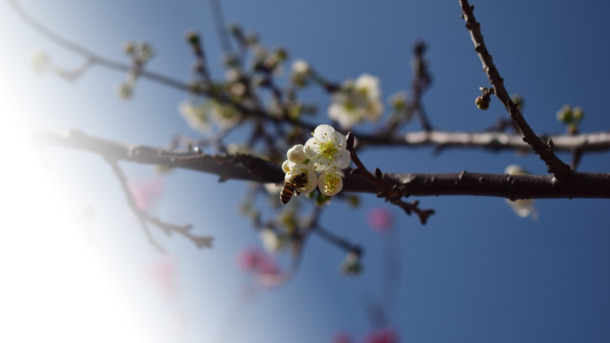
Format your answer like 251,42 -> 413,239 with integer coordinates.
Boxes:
282,125 -> 351,202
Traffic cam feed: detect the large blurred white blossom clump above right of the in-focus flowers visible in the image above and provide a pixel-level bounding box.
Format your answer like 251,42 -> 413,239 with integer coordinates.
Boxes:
328,74 -> 383,128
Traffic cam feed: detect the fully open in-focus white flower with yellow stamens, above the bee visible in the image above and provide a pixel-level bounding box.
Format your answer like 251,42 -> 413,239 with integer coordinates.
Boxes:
304,124 -> 351,172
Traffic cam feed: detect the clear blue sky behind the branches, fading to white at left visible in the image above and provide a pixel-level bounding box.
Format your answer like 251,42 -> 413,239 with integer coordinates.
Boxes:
0,0 -> 610,342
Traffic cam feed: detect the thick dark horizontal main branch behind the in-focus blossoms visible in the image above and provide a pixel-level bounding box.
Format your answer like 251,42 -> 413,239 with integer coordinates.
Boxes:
36,131 -> 610,200
